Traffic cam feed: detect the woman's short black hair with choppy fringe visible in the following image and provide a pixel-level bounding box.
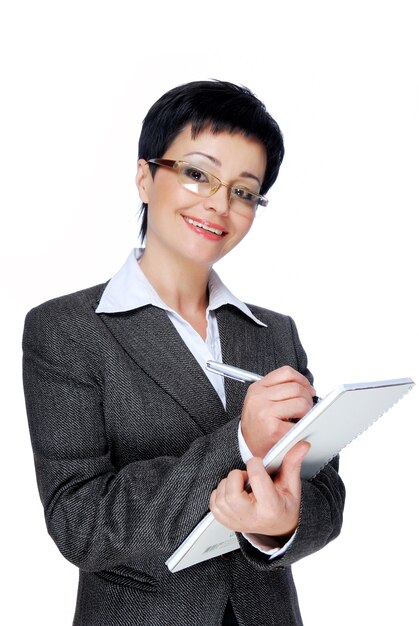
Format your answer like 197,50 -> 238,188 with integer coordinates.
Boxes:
138,80 -> 284,240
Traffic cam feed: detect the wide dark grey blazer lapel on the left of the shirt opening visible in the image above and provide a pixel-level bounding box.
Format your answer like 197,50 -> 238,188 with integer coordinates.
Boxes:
95,306 -> 228,433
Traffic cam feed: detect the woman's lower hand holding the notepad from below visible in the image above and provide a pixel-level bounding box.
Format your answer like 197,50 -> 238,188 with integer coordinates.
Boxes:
210,441 -> 310,537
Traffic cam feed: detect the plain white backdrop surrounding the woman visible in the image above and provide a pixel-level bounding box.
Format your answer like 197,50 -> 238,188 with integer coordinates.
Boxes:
0,0 -> 419,626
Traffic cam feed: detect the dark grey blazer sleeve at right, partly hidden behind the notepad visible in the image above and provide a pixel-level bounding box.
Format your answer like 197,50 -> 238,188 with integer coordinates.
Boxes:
238,318 -> 345,570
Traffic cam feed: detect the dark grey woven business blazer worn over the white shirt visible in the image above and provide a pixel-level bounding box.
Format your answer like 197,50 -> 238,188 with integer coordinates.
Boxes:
23,285 -> 344,626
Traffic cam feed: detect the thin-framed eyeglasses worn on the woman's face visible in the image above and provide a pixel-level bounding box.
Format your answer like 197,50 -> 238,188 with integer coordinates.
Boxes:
147,159 -> 268,215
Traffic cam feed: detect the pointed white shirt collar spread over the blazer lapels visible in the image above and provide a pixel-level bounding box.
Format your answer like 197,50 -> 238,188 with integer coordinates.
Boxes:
96,248 -> 266,327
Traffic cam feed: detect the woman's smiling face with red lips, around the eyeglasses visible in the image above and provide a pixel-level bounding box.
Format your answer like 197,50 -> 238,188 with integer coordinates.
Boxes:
136,126 -> 266,267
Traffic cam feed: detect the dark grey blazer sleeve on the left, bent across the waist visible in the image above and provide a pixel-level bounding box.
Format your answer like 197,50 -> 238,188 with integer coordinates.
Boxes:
23,305 -> 243,571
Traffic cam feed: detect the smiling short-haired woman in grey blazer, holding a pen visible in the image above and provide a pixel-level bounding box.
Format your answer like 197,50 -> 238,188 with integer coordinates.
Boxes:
24,81 -> 344,626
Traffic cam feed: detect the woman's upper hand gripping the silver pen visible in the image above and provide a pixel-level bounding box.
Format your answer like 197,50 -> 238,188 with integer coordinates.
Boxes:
241,366 -> 316,458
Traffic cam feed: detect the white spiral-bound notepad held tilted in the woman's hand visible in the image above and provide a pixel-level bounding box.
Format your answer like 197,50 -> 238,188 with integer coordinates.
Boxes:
166,378 -> 415,572
